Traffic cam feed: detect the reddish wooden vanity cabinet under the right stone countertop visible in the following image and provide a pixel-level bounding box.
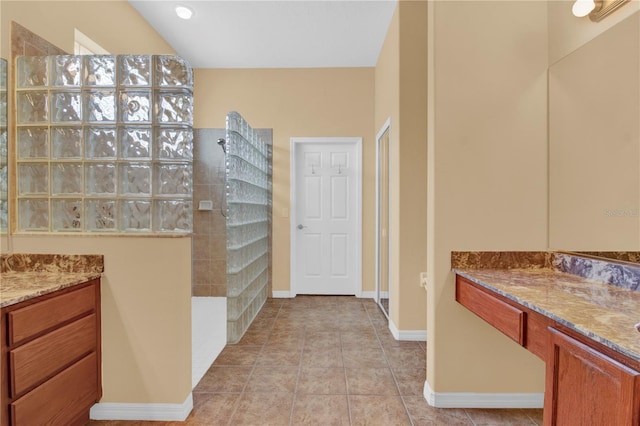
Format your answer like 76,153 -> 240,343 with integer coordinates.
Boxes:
456,276 -> 640,426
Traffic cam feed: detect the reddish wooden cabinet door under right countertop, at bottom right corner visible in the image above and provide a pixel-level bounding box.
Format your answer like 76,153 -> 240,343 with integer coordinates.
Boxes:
544,328 -> 640,426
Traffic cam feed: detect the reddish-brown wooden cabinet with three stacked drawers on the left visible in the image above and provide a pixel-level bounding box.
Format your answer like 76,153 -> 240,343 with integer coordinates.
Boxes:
0,279 -> 102,426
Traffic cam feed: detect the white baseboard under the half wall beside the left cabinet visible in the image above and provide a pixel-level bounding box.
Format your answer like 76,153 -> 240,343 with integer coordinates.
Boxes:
89,393 -> 193,422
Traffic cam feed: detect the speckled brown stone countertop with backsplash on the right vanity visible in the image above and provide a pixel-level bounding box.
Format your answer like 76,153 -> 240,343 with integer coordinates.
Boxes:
452,252 -> 640,362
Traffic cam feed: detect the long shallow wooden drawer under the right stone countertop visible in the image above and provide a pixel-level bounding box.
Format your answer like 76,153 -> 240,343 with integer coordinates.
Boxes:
456,277 -> 526,345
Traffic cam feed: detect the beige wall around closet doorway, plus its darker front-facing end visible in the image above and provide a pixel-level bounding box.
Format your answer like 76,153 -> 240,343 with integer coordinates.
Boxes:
375,1 -> 427,330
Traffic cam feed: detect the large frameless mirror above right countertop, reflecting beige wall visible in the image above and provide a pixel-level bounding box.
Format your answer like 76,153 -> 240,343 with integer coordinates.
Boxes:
549,12 -> 640,251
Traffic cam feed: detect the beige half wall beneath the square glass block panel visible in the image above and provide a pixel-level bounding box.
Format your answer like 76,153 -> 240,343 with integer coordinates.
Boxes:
12,235 -> 191,404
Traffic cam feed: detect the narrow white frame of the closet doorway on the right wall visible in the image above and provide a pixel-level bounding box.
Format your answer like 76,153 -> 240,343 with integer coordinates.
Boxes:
375,117 -> 392,318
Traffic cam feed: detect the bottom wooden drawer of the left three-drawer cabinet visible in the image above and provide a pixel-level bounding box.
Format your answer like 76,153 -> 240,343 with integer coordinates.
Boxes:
11,353 -> 98,426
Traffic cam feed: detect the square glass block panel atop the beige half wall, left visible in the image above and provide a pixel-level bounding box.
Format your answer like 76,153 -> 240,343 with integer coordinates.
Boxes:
16,55 -> 193,233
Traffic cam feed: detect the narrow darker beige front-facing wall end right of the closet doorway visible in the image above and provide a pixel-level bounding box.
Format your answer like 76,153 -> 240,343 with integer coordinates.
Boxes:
392,1 -> 427,330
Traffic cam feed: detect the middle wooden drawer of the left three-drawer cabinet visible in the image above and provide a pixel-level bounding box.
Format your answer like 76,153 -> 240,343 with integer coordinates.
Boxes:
9,314 -> 96,397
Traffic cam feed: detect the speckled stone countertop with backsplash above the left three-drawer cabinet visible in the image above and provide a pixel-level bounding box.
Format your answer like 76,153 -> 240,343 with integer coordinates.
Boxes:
0,254 -> 104,308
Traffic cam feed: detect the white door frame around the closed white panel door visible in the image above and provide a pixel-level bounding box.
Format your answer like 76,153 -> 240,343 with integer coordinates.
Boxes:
289,137 -> 362,297
